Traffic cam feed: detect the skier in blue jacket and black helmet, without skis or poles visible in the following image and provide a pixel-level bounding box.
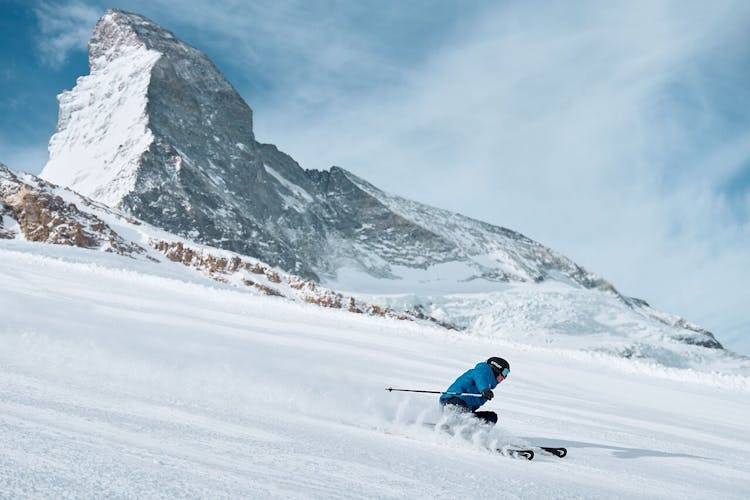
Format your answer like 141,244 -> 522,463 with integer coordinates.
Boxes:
440,357 -> 510,424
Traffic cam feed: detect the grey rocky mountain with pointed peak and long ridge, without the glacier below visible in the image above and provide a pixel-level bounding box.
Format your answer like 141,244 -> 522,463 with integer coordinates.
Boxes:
33,10 -> 721,347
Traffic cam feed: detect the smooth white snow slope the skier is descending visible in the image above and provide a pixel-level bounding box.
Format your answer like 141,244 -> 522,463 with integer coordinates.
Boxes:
0,241 -> 750,500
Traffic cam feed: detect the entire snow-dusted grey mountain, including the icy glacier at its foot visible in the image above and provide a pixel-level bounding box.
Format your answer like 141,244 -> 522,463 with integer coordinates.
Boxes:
35,10 -> 736,364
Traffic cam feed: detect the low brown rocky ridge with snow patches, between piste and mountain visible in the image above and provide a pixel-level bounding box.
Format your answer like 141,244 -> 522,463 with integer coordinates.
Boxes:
0,163 -> 428,327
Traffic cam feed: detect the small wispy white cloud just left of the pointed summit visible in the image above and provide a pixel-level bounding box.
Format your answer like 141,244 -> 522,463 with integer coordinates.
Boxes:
34,1 -> 102,68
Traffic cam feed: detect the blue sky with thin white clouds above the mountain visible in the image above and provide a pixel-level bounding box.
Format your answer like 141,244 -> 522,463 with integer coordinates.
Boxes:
0,0 -> 750,354
